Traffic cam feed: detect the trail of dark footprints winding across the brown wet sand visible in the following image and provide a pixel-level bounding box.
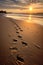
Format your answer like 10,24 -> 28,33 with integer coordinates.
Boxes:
9,22 -> 40,65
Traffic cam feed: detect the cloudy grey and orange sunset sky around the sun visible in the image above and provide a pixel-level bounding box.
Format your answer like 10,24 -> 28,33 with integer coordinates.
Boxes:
0,0 -> 43,13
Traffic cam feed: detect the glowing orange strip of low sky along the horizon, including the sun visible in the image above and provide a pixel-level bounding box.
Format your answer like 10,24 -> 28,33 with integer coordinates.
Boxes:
0,7 -> 43,13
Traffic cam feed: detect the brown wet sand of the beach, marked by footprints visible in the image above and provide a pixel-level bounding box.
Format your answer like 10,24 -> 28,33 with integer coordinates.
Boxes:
0,16 -> 43,65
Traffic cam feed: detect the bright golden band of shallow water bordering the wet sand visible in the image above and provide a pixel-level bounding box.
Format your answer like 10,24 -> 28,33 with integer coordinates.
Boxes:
5,14 -> 43,25
